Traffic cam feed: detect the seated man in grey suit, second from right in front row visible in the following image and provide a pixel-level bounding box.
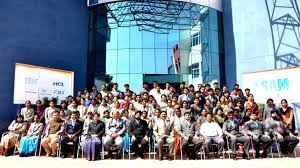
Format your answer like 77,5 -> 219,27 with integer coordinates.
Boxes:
245,113 -> 272,158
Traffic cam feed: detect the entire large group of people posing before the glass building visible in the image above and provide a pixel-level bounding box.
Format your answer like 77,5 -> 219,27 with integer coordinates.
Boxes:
0,81 -> 299,160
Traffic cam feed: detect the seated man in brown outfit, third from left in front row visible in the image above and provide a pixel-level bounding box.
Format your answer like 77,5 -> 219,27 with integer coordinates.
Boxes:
41,111 -> 64,157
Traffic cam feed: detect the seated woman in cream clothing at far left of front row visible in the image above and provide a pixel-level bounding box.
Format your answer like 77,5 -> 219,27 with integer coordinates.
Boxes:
0,114 -> 26,156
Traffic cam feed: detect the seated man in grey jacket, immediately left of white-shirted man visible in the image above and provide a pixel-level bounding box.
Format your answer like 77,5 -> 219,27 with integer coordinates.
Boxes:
178,112 -> 202,159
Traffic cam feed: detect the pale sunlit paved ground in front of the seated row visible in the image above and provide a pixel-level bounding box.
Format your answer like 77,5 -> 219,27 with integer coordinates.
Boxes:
0,156 -> 300,168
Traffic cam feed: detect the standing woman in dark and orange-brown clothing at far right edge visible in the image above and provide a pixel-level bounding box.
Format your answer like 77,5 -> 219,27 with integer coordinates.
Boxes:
279,99 -> 295,134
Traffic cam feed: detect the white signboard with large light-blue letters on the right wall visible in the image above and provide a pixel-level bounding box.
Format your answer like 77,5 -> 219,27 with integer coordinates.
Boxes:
242,68 -> 300,103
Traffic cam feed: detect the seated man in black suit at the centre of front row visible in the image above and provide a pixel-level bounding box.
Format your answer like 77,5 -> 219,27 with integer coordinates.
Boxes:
128,111 -> 149,159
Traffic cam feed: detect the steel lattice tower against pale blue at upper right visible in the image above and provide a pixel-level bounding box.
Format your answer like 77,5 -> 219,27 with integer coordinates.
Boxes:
265,0 -> 300,69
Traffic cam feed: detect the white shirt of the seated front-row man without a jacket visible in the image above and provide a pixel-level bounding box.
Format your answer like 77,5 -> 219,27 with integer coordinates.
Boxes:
200,121 -> 223,137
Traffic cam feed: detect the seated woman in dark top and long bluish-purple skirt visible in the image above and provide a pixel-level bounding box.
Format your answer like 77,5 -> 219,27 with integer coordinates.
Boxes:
83,113 -> 105,161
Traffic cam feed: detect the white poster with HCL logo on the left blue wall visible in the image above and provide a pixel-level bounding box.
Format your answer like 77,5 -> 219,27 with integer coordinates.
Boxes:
14,63 -> 74,104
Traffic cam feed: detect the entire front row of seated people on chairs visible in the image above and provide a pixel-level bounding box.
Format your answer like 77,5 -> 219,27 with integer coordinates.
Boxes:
0,110 -> 299,160
